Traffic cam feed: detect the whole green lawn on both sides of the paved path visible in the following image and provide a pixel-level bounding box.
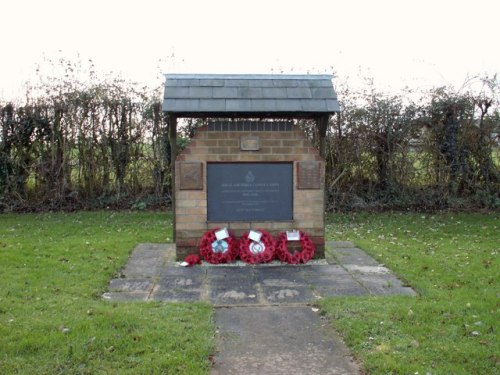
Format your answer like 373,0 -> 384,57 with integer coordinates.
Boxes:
0,212 -> 500,375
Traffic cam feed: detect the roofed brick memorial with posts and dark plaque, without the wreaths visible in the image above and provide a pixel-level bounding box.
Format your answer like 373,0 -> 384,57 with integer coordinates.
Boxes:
163,74 -> 339,259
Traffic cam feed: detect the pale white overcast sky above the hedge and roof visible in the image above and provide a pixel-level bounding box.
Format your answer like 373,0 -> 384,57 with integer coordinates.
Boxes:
0,0 -> 500,99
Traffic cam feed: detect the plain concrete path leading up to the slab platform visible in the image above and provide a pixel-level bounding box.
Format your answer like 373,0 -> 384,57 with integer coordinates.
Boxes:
212,306 -> 361,375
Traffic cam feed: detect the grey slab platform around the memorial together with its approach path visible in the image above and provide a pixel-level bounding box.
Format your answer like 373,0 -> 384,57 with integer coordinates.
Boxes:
103,242 -> 416,375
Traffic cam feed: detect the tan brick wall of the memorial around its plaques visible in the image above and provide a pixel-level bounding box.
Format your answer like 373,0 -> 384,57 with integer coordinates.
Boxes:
175,122 -> 325,259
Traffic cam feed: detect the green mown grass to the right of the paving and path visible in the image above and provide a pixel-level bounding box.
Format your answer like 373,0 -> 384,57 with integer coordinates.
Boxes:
321,214 -> 500,375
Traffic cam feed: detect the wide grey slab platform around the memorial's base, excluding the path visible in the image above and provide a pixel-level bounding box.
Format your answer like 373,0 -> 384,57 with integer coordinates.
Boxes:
103,241 -> 415,307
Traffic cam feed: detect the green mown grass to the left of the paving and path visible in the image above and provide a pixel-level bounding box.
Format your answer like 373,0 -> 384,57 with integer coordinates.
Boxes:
0,212 -> 214,374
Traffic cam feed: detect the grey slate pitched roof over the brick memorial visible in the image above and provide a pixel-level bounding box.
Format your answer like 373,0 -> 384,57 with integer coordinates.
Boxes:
163,74 -> 339,117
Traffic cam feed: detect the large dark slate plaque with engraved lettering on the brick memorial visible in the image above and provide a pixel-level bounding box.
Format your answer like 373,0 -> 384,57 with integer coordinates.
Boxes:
207,163 -> 293,222
